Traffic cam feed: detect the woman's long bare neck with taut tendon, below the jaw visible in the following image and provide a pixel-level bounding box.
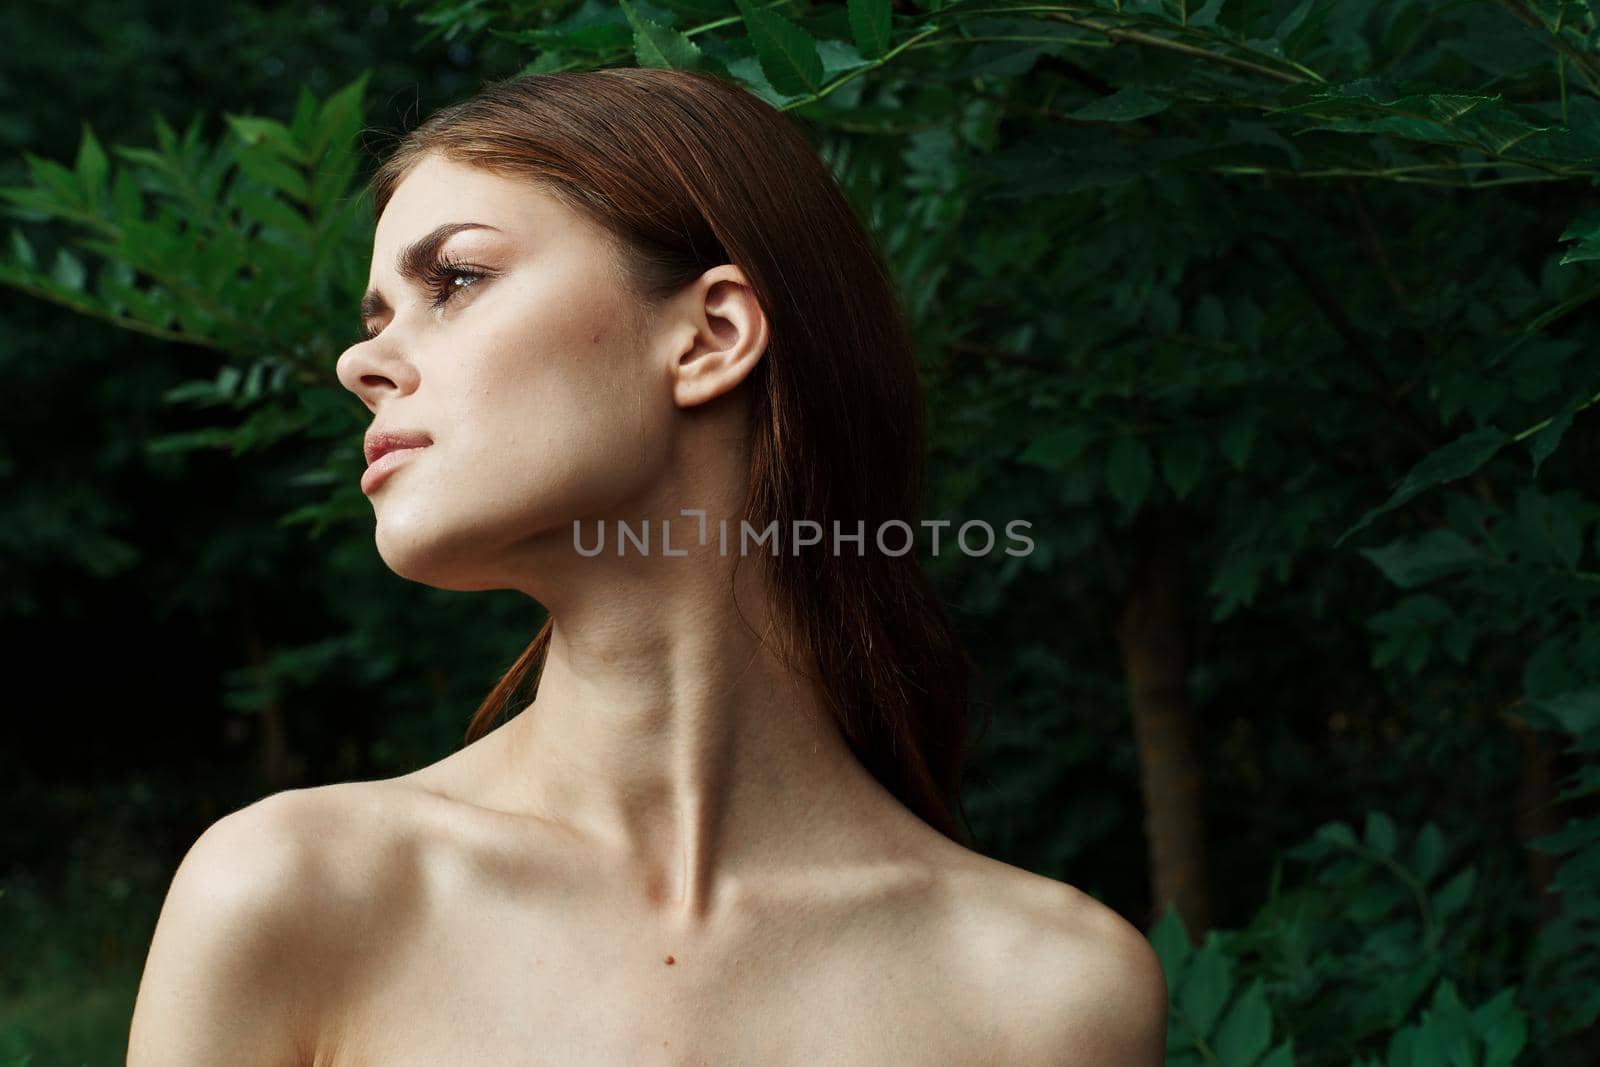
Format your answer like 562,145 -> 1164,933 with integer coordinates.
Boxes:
473,526 -> 914,926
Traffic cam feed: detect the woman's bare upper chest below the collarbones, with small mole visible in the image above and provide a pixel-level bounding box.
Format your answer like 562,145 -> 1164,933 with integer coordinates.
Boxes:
315,905 -> 1000,1067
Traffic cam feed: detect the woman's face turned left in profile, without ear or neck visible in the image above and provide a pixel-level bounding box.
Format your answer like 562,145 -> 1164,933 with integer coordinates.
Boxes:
338,155 -> 675,590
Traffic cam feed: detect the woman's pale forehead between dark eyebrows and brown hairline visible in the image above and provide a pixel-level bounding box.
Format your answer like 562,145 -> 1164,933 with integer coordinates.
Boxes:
373,155 -> 582,267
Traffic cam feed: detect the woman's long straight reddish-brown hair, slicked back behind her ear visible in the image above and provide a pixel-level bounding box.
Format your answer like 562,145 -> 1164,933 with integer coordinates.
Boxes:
371,67 -> 989,846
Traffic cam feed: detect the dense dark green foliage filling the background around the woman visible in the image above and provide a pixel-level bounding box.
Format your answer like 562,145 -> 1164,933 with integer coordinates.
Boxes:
0,0 -> 1600,1067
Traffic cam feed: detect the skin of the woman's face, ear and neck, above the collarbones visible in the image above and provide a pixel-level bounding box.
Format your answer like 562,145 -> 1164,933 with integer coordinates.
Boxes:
338,158 -> 893,933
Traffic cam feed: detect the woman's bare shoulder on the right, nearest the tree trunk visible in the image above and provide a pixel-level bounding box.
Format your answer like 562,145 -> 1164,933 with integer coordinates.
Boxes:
940,857 -> 1166,1067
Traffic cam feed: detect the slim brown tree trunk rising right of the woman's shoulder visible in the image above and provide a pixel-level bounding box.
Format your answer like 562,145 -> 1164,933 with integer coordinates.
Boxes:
1117,507 -> 1211,941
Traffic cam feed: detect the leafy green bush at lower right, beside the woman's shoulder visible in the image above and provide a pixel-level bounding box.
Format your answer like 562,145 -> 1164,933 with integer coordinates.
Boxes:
1150,811 -> 1528,1067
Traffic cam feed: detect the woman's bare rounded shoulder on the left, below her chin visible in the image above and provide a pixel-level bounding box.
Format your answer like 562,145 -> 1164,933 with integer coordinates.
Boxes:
128,782 -> 422,1067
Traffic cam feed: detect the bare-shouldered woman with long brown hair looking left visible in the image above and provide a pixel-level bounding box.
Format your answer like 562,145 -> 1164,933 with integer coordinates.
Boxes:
130,69 -> 1166,1067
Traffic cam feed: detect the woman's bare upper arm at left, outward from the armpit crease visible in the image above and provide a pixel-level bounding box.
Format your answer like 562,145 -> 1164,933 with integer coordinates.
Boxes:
128,793 -> 326,1067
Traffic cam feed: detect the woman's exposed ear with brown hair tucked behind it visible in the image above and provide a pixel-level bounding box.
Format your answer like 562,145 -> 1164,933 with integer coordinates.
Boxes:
672,262 -> 768,408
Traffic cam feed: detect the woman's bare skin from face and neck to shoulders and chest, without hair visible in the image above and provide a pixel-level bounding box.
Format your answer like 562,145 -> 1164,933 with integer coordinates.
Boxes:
130,157 -> 1165,1067
